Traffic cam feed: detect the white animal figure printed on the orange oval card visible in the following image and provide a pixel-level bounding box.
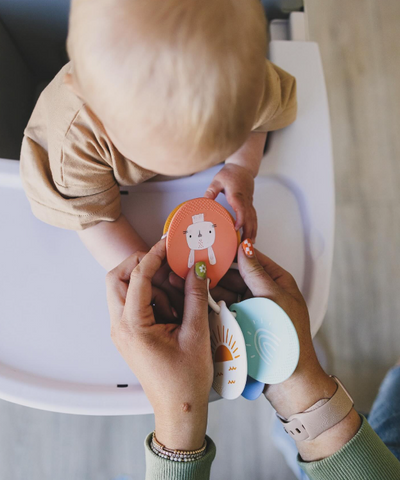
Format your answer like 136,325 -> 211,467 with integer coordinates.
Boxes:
184,213 -> 217,268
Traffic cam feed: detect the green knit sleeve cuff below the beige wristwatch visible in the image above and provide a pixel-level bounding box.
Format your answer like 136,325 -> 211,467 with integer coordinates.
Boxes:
298,415 -> 400,480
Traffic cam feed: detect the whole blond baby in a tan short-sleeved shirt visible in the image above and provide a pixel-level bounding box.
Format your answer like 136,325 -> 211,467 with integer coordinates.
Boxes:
21,0 -> 296,270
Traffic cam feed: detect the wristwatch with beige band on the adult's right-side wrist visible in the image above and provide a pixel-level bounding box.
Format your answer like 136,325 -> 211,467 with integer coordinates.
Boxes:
276,375 -> 354,442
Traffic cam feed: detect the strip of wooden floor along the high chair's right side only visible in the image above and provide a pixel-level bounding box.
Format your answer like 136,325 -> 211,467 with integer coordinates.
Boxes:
307,0 -> 400,410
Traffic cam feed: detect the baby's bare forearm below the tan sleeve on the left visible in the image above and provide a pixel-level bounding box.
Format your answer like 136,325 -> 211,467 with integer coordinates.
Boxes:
78,215 -> 149,271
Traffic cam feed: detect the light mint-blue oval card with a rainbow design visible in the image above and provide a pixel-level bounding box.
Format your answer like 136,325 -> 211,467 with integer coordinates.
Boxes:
229,298 -> 300,384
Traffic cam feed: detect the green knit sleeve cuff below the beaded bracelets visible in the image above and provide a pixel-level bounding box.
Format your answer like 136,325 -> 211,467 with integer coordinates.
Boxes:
144,433 -> 216,480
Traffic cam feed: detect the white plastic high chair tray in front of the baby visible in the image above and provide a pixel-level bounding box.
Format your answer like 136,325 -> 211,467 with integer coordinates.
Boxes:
0,41 -> 334,415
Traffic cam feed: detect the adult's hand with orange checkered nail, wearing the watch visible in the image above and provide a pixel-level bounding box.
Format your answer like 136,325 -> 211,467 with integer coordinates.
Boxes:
238,240 -> 361,461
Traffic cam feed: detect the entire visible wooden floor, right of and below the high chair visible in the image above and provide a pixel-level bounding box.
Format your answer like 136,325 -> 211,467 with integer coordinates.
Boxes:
0,0 -> 400,480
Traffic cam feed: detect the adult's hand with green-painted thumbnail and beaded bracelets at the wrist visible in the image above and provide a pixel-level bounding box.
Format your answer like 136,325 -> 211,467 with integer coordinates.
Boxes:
107,240 -> 213,450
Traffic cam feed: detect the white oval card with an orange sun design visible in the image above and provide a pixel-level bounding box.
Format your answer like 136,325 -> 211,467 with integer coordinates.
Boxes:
209,302 -> 247,400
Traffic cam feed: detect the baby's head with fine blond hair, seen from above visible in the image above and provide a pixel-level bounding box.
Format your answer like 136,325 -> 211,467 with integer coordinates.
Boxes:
68,0 -> 266,175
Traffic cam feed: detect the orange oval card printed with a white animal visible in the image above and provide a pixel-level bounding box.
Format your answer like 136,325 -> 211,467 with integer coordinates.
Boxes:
164,198 -> 239,287
